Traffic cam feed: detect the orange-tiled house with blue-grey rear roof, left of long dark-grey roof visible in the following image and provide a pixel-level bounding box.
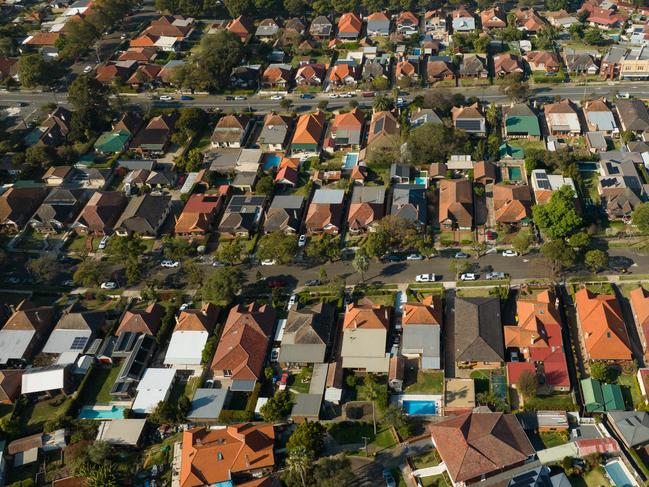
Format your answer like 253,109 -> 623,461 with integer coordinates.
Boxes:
401,295 -> 444,370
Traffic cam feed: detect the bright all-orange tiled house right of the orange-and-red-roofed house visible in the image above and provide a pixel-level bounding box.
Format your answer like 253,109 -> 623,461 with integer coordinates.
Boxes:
575,288 -> 632,360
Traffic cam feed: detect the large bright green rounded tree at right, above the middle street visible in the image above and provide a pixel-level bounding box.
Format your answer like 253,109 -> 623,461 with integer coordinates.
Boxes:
532,186 -> 583,238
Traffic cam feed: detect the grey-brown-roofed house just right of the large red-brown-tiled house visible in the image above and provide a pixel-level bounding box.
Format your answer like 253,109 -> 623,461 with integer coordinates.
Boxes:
279,303 -> 335,364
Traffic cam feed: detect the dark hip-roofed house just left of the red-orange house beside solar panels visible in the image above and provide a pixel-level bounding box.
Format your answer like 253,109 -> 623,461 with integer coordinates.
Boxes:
115,194 -> 171,238
